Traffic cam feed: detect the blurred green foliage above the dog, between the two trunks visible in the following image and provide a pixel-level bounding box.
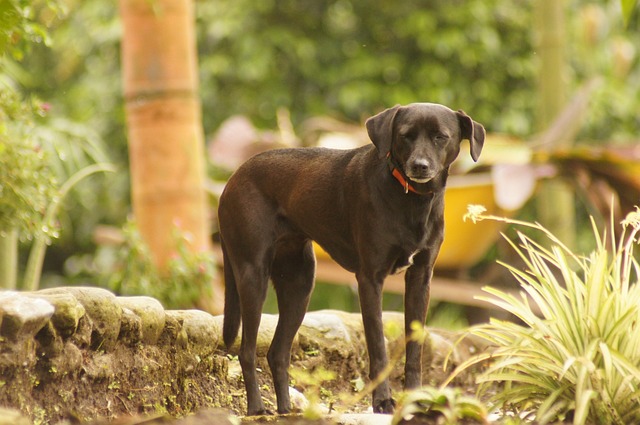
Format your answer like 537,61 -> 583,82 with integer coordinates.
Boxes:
197,0 -> 535,134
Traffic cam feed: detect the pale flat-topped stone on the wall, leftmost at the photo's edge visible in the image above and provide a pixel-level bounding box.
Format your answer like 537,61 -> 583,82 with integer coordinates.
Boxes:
0,291 -> 54,341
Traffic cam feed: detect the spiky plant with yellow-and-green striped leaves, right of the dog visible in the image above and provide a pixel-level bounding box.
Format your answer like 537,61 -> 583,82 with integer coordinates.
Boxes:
448,205 -> 640,424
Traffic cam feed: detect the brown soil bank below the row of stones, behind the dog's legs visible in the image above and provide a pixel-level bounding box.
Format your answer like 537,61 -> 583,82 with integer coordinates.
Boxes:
0,338 -> 480,425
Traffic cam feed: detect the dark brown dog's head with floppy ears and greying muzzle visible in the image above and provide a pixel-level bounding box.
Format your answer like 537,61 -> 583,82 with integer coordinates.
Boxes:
366,103 -> 485,183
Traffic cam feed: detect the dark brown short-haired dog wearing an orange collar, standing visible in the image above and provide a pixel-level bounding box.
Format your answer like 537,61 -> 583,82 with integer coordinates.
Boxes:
219,103 -> 485,415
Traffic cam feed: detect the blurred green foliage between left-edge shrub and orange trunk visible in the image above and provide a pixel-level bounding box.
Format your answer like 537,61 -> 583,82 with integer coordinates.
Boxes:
5,0 -> 129,252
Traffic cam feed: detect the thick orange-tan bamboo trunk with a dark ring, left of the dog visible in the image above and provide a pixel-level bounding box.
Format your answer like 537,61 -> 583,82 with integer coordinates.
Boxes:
120,0 -> 220,310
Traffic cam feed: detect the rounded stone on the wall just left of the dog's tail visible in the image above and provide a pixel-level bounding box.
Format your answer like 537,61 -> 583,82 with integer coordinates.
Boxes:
166,310 -> 221,357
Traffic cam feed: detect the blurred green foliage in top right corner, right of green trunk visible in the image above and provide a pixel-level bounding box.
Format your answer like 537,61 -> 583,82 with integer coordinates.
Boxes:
566,0 -> 640,144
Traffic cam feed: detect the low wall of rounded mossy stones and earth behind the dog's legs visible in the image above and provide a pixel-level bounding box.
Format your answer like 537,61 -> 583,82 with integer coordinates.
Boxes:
0,287 -> 474,424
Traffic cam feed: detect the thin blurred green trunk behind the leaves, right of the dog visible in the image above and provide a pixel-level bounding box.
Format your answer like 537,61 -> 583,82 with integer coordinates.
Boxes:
535,0 -> 575,247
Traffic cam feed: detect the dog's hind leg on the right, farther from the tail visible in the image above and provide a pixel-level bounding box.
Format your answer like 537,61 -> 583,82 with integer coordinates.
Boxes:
267,241 -> 315,413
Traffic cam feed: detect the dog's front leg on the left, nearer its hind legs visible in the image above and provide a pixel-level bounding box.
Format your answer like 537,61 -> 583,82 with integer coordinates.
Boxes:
356,274 -> 395,413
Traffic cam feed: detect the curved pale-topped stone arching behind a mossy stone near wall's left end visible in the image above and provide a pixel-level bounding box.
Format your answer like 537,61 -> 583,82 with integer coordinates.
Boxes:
40,286 -> 122,351
